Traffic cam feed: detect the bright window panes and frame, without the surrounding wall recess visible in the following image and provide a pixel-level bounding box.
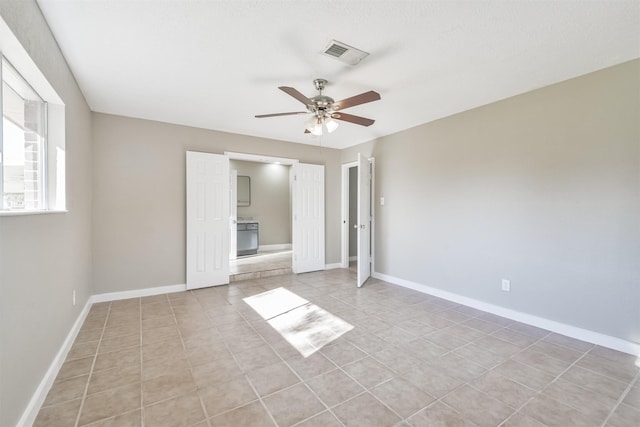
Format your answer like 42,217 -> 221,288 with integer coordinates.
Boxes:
0,58 -> 48,211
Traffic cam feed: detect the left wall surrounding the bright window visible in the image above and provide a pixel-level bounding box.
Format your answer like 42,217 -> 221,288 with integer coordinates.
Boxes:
0,0 -> 93,426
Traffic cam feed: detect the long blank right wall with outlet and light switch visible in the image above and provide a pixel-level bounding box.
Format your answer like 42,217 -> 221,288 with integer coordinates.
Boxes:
342,60 -> 640,343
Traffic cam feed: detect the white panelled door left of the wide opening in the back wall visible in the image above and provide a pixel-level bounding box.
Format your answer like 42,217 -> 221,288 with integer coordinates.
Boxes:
187,151 -> 229,289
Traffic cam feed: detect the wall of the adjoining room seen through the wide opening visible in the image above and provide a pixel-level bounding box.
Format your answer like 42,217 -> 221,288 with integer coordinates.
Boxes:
230,160 -> 291,246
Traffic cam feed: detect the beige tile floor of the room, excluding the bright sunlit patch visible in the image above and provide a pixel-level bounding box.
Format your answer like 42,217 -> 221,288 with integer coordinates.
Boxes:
35,270 -> 640,427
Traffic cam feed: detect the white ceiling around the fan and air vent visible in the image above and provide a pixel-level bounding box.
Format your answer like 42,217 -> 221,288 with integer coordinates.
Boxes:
38,0 -> 640,148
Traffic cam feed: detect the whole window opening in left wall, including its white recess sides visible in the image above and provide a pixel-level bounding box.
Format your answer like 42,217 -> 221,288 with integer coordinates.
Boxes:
0,13 -> 66,216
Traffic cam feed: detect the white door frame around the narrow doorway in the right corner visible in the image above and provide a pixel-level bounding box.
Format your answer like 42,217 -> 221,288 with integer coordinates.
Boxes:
340,157 -> 376,276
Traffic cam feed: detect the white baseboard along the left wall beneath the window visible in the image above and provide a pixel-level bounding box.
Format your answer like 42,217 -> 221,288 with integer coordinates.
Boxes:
17,298 -> 92,427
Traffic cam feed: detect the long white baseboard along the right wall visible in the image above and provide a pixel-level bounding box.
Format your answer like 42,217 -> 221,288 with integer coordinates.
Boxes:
372,272 -> 640,356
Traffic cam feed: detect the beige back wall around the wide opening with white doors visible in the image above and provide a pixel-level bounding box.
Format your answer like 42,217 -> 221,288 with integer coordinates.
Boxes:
93,113 -> 340,294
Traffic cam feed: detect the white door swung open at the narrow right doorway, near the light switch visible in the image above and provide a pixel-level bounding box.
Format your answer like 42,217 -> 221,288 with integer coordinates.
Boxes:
357,153 -> 371,287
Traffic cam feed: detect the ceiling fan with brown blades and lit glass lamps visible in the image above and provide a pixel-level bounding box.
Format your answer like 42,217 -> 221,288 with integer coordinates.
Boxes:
256,79 -> 380,135
